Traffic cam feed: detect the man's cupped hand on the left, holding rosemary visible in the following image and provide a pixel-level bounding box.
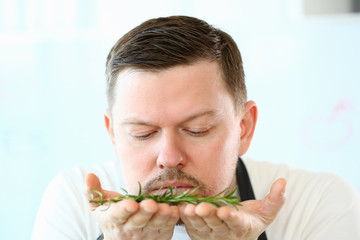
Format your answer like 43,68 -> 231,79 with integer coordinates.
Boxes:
85,173 -> 180,240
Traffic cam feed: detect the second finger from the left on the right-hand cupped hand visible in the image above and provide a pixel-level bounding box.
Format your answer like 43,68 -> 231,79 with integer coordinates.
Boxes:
195,202 -> 228,232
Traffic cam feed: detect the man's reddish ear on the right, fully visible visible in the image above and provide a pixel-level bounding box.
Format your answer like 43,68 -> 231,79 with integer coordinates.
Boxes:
239,101 -> 258,156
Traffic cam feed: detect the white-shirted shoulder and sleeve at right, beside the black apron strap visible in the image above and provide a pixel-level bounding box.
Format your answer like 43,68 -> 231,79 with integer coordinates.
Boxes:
244,159 -> 360,239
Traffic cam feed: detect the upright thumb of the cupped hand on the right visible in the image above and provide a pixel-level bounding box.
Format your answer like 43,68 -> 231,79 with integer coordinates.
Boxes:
263,178 -> 286,222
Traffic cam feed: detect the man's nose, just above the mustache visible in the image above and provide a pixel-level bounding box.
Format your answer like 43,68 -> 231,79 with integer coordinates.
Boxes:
157,133 -> 186,169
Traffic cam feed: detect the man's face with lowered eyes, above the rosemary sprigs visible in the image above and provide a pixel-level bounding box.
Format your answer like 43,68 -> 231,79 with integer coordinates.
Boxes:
106,61 -> 246,195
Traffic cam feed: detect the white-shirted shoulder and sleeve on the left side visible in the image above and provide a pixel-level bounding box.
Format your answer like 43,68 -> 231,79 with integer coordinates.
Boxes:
33,161 -> 124,239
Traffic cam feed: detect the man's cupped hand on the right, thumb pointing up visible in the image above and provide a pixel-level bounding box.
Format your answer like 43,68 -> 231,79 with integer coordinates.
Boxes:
180,178 -> 286,240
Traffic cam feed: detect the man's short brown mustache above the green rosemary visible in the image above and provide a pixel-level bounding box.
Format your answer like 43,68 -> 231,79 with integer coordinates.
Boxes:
142,168 -> 210,196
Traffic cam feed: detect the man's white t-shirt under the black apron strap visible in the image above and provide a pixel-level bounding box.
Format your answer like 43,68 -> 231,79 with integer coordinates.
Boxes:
33,159 -> 360,240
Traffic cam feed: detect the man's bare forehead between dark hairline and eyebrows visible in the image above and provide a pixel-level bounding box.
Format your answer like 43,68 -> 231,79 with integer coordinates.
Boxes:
112,61 -> 233,122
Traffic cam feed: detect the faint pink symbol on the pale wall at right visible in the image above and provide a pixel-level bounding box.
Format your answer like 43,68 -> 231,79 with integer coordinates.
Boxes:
302,99 -> 355,151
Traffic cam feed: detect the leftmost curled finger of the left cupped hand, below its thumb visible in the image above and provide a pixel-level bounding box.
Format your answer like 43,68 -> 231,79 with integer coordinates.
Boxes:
94,199 -> 140,226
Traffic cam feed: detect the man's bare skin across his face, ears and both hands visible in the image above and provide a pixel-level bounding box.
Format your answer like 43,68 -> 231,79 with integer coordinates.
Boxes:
86,60 -> 286,239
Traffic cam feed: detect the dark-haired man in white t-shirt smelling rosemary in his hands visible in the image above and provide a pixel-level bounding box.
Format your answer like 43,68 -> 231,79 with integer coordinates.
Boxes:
33,16 -> 360,240
